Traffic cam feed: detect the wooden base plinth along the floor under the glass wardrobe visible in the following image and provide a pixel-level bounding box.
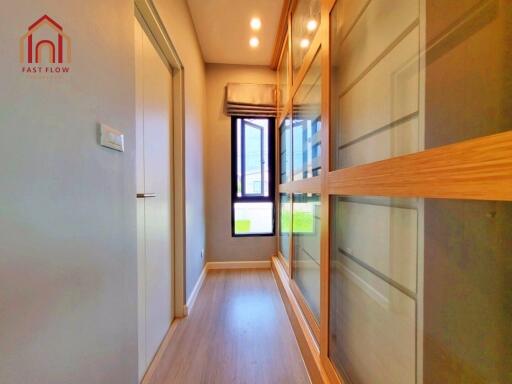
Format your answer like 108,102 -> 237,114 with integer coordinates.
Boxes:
272,257 -> 330,384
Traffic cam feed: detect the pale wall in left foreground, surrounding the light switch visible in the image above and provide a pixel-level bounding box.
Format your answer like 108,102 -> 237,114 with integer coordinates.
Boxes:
0,0 -> 137,384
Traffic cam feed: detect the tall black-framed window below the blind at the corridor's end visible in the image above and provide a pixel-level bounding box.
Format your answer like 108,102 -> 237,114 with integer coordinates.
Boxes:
231,116 -> 275,236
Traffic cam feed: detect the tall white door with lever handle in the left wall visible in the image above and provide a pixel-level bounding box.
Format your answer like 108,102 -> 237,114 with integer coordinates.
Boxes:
135,18 -> 173,378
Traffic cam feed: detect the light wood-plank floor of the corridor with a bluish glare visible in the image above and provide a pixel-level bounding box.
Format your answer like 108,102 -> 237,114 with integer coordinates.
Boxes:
146,270 -> 310,384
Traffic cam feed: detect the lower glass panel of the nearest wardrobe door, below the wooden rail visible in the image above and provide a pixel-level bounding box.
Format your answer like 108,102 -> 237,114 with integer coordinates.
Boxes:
329,196 -> 512,384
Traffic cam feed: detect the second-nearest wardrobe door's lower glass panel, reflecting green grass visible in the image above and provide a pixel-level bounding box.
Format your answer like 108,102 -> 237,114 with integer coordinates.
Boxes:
293,194 -> 320,320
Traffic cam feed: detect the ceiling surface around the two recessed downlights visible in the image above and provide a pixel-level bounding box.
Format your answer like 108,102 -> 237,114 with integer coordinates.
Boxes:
187,0 -> 283,65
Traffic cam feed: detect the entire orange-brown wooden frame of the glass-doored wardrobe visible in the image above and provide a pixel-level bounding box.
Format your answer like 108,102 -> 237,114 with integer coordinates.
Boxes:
271,0 -> 512,383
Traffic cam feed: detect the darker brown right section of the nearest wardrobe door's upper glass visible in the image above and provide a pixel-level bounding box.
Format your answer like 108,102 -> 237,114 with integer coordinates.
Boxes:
425,0 -> 512,148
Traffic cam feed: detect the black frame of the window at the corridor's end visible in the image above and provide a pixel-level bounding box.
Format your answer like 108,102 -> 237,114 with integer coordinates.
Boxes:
231,116 -> 276,237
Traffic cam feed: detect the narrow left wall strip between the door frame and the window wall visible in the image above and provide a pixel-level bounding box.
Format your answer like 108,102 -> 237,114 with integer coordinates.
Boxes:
154,0 -> 206,297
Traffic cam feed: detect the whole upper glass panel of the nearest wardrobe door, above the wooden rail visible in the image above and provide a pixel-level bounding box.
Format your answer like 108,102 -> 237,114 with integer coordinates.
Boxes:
329,0 -> 512,168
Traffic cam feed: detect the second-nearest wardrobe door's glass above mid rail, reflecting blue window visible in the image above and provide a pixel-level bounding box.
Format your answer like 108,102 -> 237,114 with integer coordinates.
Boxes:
293,52 -> 322,180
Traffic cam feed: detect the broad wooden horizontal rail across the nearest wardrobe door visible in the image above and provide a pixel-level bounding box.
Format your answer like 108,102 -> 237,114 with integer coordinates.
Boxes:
327,131 -> 512,201
